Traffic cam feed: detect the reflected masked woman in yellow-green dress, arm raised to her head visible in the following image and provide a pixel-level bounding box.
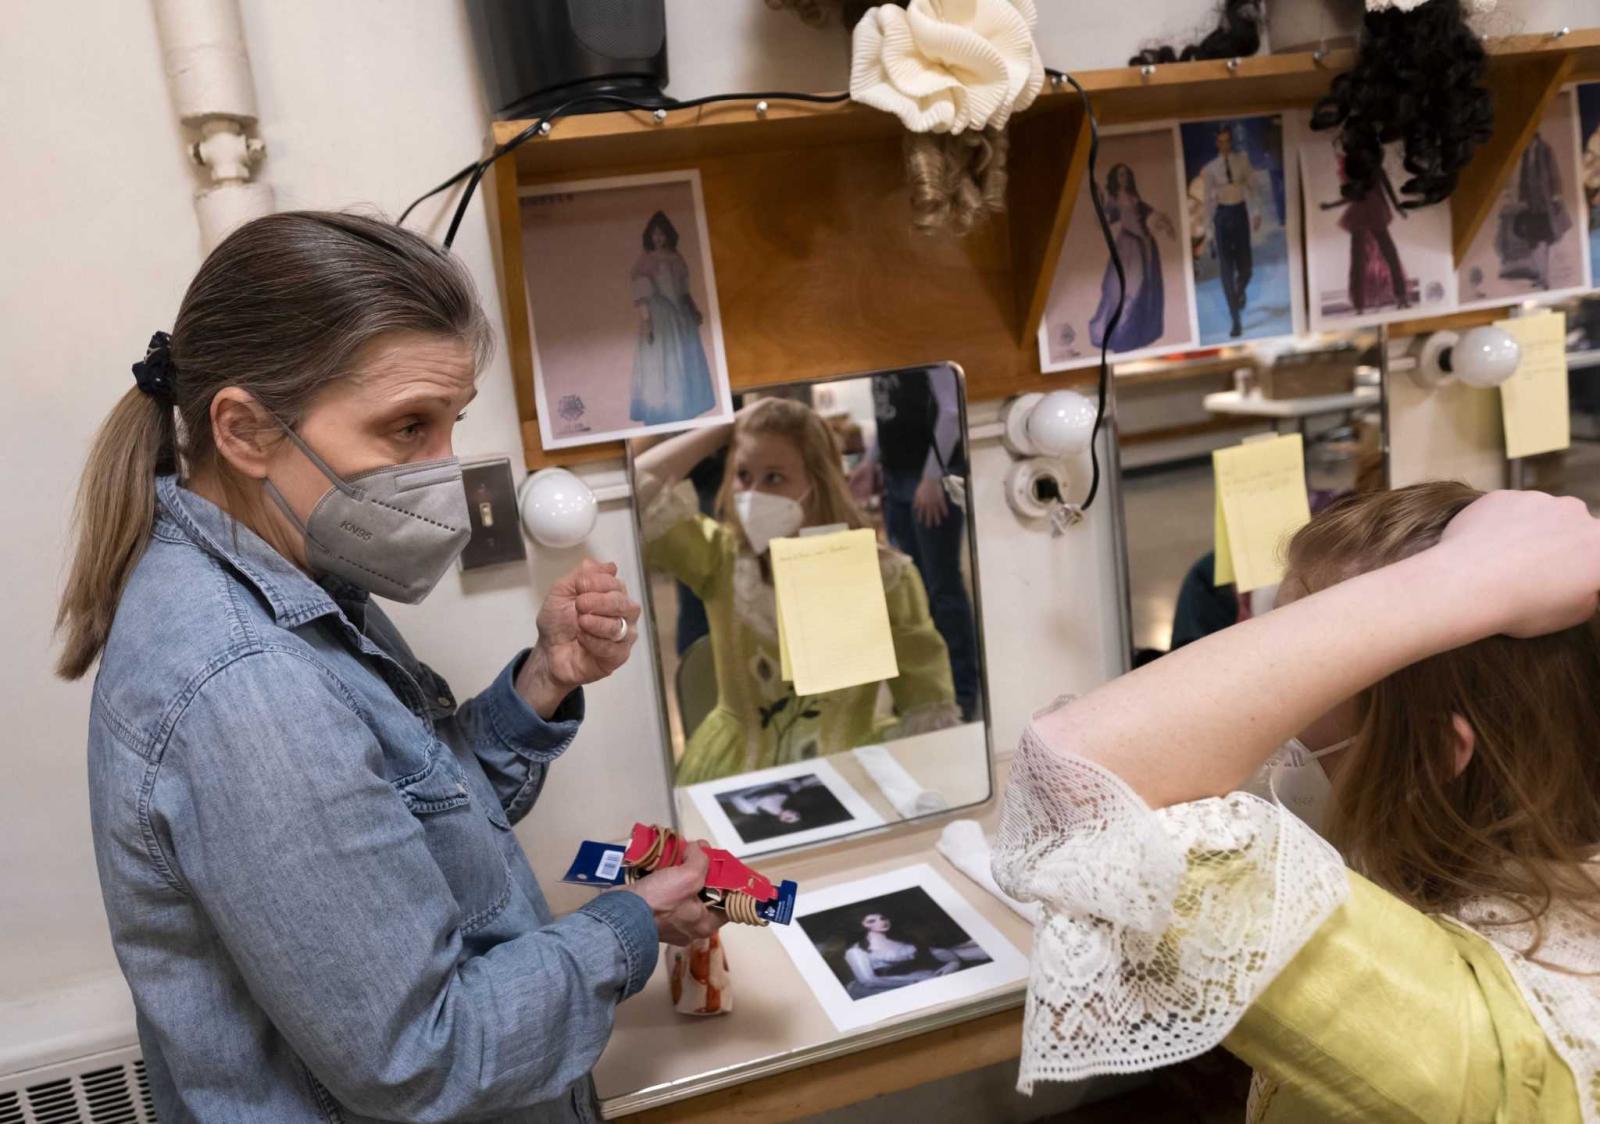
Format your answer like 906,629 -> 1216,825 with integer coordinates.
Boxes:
637,399 -> 960,785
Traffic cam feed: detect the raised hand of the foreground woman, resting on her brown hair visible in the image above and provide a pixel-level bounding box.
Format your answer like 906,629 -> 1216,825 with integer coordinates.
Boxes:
1430,492 -> 1600,637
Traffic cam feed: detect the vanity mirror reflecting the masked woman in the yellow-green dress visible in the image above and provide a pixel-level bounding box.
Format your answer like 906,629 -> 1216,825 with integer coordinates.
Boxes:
627,363 -> 990,855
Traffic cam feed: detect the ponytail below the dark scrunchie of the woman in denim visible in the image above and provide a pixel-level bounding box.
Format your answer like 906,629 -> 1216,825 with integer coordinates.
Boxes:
56,387 -> 178,679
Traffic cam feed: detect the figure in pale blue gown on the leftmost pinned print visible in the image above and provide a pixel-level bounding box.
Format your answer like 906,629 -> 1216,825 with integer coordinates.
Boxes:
629,211 -> 717,426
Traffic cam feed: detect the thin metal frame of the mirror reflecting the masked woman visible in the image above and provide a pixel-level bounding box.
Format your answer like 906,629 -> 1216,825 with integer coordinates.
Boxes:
622,360 -> 997,860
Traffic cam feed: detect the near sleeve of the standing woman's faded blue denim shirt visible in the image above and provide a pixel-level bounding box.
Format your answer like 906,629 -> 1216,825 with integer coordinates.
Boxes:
149,650 -> 656,1121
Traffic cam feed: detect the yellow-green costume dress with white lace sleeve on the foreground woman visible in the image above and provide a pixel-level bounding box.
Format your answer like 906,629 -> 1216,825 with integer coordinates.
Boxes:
995,714 -> 1600,1124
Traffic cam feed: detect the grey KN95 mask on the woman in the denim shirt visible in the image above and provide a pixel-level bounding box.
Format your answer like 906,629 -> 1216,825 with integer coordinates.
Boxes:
266,426 -> 472,605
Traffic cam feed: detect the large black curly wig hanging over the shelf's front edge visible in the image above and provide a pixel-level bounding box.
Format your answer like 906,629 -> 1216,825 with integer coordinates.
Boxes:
1310,0 -> 1494,207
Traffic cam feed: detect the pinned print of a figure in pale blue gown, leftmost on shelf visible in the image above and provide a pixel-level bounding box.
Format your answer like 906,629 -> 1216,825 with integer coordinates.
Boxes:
522,170 -> 733,448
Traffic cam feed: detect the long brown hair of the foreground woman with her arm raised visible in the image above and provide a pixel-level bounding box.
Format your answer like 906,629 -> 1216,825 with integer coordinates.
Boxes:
1288,484 -> 1600,941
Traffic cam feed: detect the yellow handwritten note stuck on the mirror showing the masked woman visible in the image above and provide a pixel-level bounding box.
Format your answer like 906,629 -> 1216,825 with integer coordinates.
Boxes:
771,530 -> 899,695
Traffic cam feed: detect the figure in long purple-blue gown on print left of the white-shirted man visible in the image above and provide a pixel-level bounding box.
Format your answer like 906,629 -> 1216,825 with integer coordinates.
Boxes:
1090,163 -> 1178,352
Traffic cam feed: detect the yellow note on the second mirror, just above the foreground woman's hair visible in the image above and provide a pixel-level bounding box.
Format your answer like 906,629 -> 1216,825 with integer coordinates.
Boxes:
1211,434 -> 1310,592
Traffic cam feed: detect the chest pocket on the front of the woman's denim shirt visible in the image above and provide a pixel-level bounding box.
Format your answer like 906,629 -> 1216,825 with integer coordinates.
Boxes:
395,740 -> 510,935
